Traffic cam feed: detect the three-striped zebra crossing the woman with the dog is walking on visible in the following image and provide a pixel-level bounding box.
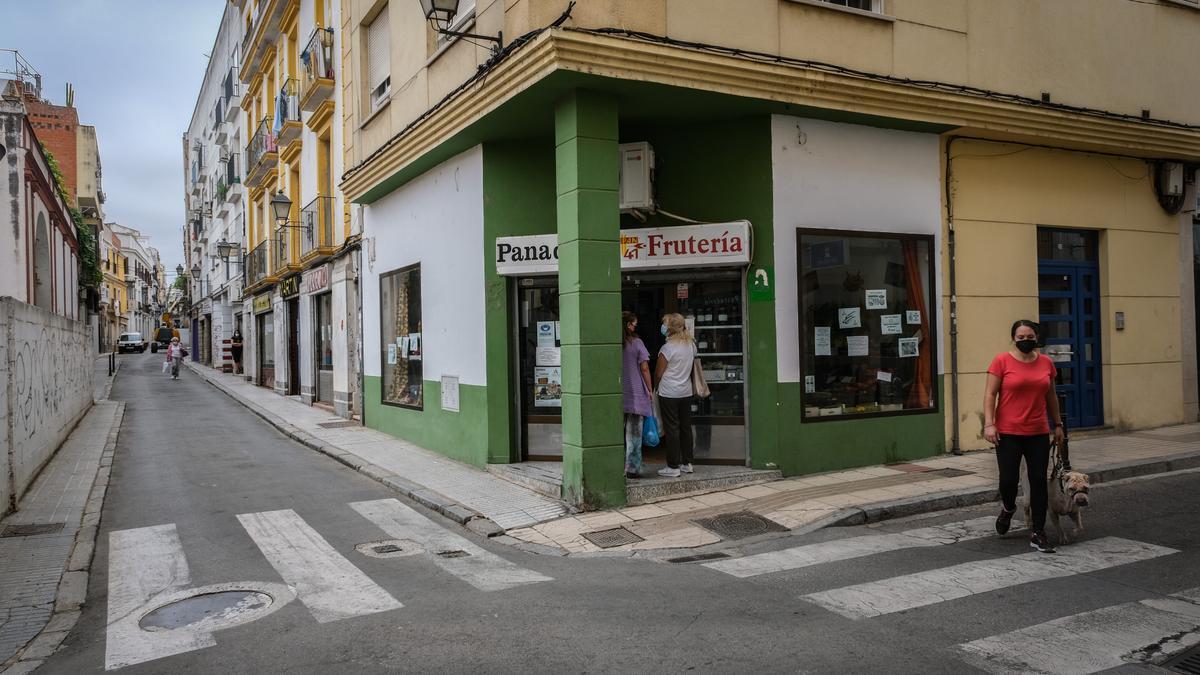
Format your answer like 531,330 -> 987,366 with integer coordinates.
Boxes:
703,516 -> 1200,674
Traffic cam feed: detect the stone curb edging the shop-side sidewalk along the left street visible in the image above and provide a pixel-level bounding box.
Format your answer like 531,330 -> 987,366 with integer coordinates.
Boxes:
186,362 -> 504,537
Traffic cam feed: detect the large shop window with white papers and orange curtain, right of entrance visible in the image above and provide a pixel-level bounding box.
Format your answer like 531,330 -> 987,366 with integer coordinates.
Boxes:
797,229 -> 937,420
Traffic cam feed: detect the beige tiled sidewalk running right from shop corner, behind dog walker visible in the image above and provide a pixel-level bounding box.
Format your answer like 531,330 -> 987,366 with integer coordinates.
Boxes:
500,424 -> 1200,557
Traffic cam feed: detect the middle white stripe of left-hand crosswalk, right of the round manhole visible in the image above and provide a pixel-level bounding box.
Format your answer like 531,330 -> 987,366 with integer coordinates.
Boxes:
238,509 -> 404,623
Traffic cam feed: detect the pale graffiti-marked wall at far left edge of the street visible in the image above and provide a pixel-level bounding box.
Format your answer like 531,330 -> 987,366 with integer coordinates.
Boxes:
0,298 -> 95,514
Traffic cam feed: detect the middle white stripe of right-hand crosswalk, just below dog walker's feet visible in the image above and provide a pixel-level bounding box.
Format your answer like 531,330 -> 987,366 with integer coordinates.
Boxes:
803,537 -> 1178,619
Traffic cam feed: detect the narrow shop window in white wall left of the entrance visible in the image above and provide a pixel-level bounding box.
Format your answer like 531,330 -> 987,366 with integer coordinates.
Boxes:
379,264 -> 425,410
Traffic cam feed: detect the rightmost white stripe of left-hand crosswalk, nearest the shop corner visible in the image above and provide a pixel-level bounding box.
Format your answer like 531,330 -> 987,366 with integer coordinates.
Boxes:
350,500 -> 553,591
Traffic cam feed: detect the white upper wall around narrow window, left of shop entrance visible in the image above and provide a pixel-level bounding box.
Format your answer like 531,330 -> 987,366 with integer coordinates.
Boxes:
362,147 -> 487,384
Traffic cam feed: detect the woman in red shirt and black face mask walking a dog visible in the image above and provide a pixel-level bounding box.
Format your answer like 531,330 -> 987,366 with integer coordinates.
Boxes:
983,319 -> 1062,552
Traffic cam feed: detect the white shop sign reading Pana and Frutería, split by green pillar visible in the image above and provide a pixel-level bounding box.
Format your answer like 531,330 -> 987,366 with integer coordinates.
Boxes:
496,220 -> 751,276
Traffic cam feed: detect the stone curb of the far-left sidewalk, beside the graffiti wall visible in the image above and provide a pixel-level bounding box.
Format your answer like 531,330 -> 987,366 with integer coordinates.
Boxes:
0,401 -> 125,675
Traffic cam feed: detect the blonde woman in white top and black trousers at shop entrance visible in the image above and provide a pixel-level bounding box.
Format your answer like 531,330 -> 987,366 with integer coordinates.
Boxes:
654,313 -> 696,478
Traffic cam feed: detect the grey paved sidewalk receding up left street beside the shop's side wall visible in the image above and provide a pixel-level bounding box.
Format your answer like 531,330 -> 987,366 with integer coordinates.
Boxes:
185,362 -> 569,534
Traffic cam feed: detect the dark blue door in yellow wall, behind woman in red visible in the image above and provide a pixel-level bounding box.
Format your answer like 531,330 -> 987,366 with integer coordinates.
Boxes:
1038,228 -> 1104,428
